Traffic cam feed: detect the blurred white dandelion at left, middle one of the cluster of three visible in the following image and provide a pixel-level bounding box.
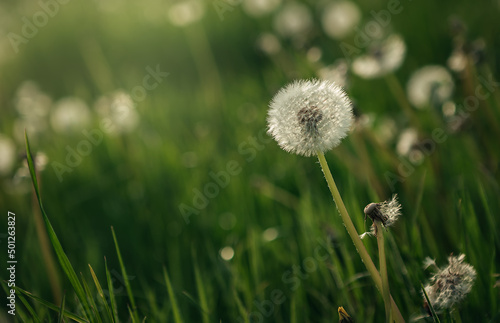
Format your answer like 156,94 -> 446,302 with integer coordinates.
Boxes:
50,97 -> 91,133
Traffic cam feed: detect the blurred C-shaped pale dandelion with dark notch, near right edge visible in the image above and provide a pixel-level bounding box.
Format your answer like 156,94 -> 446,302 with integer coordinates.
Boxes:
406,65 -> 454,109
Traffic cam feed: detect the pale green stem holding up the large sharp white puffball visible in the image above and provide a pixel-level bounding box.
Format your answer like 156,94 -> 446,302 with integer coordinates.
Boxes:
317,151 -> 404,323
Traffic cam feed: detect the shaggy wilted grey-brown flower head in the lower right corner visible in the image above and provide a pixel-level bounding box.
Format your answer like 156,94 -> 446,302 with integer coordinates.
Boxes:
424,254 -> 477,310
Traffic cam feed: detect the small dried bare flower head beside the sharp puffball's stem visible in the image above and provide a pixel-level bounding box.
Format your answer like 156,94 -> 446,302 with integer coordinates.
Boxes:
361,194 -> 401,238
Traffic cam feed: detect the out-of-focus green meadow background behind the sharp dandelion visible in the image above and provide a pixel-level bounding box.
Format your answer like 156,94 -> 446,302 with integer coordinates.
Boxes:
0,0 -> 500,322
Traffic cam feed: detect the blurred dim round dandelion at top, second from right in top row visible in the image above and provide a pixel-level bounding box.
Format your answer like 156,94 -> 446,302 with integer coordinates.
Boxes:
274,2 -> 313,38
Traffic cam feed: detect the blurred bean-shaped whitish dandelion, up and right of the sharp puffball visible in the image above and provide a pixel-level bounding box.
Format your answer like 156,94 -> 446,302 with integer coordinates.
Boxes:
352,35 -> 406,79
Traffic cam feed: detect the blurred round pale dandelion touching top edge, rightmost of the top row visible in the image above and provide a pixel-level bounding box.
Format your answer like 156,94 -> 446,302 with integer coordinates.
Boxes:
321,1 -> 361,39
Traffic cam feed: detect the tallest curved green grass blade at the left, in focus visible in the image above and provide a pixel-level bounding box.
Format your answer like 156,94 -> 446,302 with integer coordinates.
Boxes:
25,132 -> 91,318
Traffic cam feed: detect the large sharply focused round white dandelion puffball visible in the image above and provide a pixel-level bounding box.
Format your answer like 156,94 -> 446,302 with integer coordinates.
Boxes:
267,80 -> 354,156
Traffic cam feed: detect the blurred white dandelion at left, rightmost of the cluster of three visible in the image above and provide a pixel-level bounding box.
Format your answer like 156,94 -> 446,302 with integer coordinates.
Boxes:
95,91 -> 139,134
